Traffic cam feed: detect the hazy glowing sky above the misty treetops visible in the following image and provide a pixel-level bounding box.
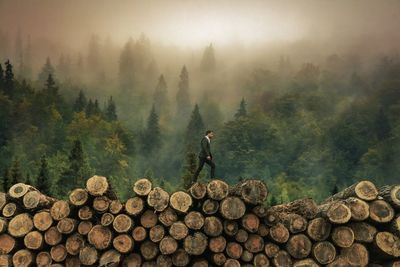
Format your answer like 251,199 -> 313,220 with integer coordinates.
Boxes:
0,0 -> 400,47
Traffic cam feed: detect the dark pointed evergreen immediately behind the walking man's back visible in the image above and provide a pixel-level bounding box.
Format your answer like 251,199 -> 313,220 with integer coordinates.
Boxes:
185,104 -> 205,152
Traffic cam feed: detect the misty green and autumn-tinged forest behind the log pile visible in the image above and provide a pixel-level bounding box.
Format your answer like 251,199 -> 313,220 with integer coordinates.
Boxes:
0,1 -> 400,203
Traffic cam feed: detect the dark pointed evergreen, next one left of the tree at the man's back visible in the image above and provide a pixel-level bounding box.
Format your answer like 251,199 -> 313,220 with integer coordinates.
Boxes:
142,105 -> 161,155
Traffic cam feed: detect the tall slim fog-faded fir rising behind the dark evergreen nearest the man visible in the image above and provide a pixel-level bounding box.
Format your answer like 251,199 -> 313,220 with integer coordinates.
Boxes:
176,66 -> 190,120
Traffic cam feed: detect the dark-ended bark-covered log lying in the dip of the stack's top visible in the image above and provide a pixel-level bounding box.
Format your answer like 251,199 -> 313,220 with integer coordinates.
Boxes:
269,198 -> 318,220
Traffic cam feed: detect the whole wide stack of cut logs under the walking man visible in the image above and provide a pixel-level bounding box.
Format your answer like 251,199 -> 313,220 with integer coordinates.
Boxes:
0,176 -> 400,267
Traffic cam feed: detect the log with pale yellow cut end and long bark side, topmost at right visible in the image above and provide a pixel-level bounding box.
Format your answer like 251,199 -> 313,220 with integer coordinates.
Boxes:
324,181 -> 378,203
